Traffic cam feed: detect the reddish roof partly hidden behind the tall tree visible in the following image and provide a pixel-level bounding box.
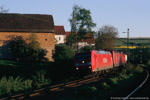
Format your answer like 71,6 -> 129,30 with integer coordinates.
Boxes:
66,32 -> 95,44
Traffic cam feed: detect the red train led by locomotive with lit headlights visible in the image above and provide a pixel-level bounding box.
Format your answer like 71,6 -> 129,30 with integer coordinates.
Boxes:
75,50 -> 127,72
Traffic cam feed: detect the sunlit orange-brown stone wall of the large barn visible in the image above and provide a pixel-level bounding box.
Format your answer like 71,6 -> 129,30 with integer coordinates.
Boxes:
0,32 -> 55,61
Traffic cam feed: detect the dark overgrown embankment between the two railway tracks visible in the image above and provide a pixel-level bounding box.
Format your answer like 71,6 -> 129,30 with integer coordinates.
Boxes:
46,65 -> 146,100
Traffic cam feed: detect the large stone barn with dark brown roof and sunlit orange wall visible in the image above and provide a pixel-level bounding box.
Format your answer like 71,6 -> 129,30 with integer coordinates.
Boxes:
0,13 -> 55,61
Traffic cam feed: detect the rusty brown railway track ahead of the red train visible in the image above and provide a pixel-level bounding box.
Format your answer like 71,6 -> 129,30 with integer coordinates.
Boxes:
0,76 -> 104,100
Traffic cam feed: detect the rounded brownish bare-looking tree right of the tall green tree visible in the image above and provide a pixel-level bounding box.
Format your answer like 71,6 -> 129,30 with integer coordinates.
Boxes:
95,25 -> 118,50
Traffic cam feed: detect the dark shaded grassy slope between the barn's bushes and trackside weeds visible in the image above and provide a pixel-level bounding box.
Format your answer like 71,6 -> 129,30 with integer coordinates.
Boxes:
0,60 -> 73,81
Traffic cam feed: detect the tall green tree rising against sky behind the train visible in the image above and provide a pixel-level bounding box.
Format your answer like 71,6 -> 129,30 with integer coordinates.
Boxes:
68,5 -> 96,46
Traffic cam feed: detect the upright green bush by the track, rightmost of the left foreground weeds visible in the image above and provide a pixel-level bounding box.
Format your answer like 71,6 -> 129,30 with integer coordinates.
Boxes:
32,70 -> 51,88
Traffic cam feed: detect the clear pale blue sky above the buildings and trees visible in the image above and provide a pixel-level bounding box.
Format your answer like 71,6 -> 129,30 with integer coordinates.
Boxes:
0,0 -> 150,37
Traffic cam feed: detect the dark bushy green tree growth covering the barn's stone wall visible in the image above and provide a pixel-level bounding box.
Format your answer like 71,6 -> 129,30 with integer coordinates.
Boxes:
5,34 -> 47,62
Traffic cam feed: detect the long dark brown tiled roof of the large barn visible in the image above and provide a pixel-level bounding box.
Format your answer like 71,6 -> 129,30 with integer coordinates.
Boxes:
0,13 -> 54,33
